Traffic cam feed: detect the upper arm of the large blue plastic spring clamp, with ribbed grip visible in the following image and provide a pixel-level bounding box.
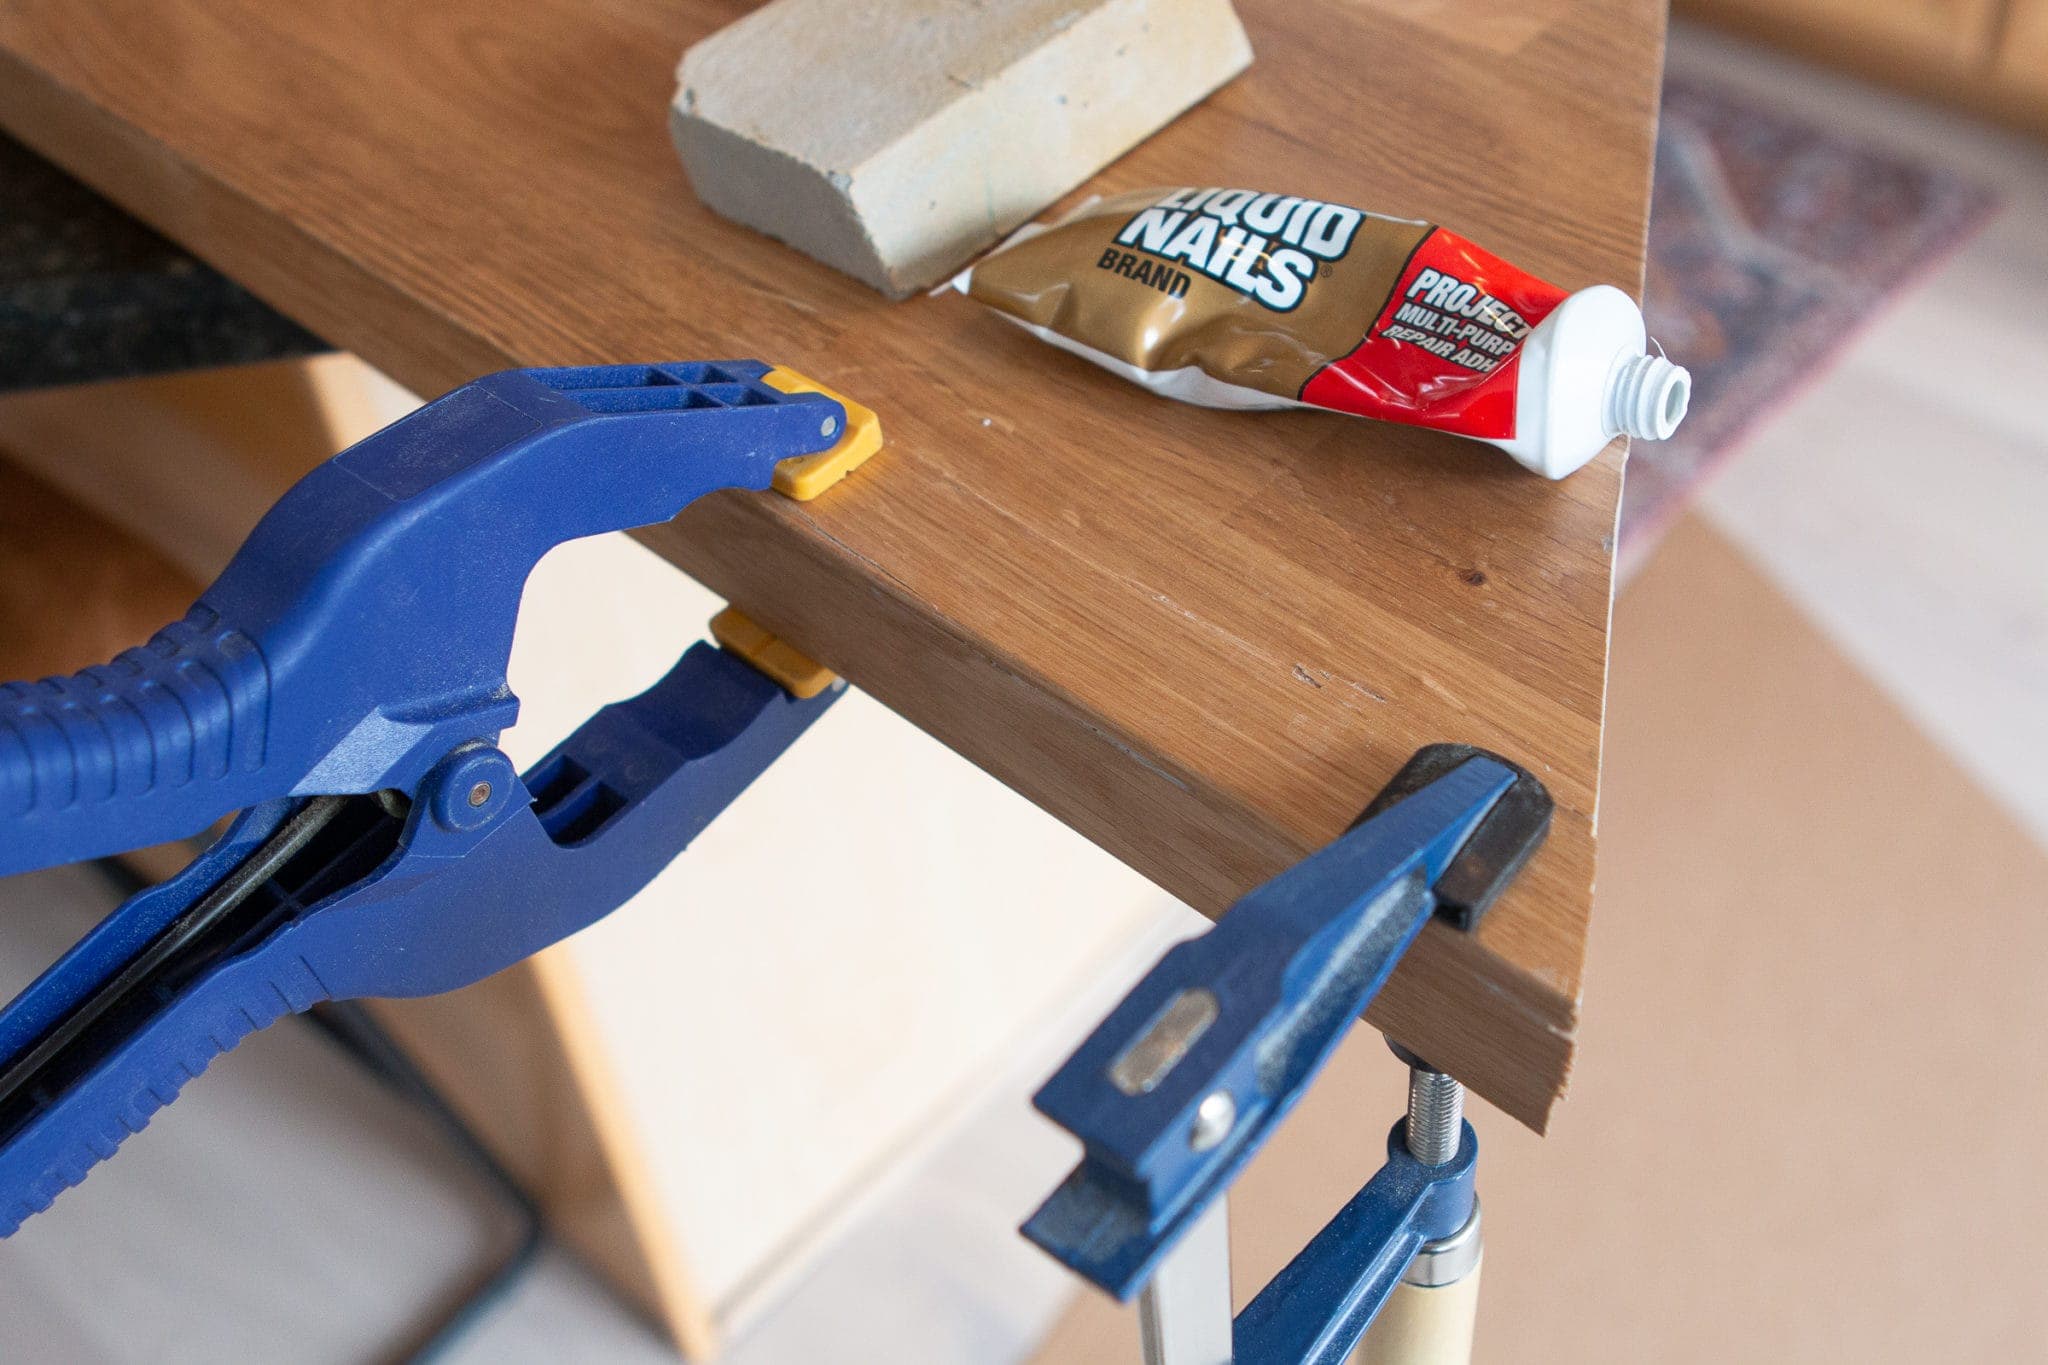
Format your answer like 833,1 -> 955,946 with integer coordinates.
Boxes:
0,360 -> 848,876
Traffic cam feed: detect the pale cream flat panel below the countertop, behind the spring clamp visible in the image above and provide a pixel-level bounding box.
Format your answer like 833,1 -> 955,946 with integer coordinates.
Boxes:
506,536 -> 1171,1312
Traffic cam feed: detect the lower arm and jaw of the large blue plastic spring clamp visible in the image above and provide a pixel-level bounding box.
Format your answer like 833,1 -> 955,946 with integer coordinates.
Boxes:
0,645 -> 844,1238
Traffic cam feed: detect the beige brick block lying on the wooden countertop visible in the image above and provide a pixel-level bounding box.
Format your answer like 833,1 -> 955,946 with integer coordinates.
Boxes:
670,0 -> 1251,297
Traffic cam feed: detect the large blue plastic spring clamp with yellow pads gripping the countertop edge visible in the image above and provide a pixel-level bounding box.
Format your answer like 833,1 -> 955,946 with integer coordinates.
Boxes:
0,360 -> 879,1236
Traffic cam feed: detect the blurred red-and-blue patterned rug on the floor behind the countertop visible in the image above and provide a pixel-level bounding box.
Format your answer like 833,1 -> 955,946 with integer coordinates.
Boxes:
1620,76 -> 1997,563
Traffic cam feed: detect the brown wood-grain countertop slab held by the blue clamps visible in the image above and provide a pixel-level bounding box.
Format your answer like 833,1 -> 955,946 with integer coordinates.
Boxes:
0,0 -> 1663,1128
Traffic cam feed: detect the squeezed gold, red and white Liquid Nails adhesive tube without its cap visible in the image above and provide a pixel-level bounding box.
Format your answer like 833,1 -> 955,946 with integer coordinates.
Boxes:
952,188 -> 1692,479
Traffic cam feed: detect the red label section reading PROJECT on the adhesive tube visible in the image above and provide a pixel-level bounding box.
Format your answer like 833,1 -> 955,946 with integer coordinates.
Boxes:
1300,227 -> 1565,440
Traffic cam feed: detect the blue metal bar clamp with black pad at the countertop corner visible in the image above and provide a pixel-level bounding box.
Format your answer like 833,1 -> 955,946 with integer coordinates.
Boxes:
1024,745 -> 1550,1365
